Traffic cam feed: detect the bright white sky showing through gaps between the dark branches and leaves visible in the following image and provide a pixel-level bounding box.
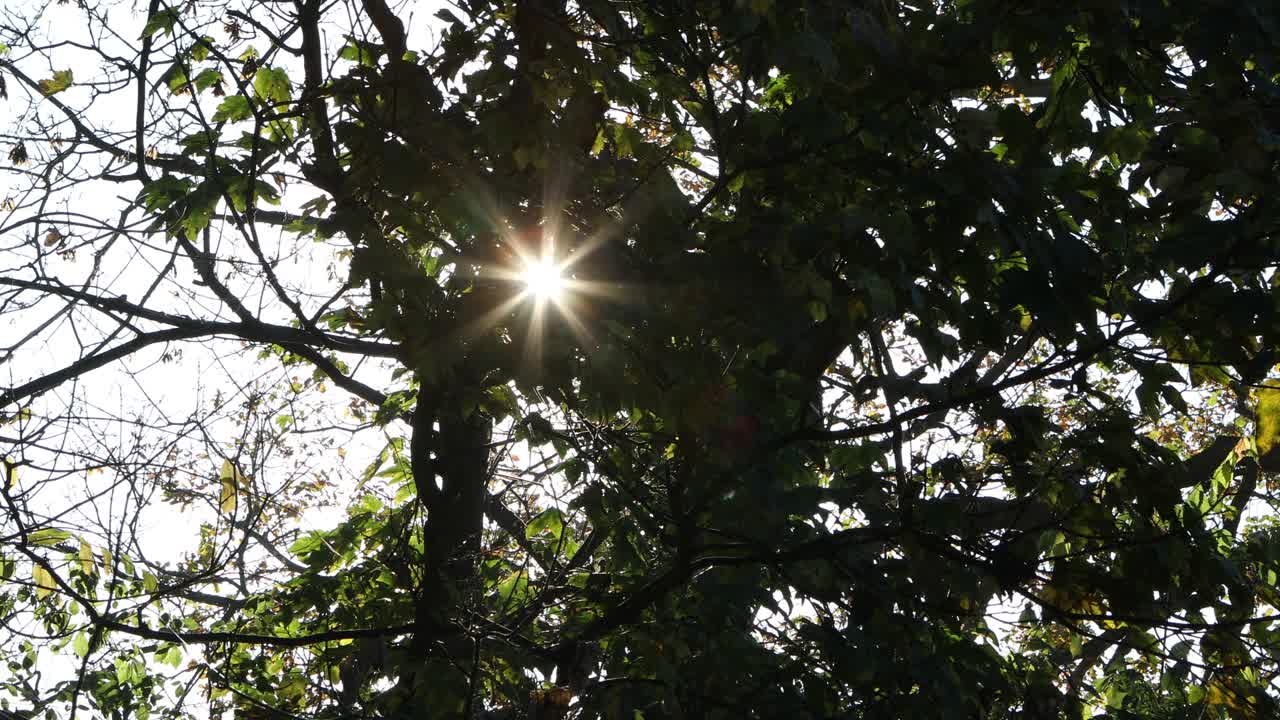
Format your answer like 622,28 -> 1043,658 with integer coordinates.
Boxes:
0,0 -> 1269,712
